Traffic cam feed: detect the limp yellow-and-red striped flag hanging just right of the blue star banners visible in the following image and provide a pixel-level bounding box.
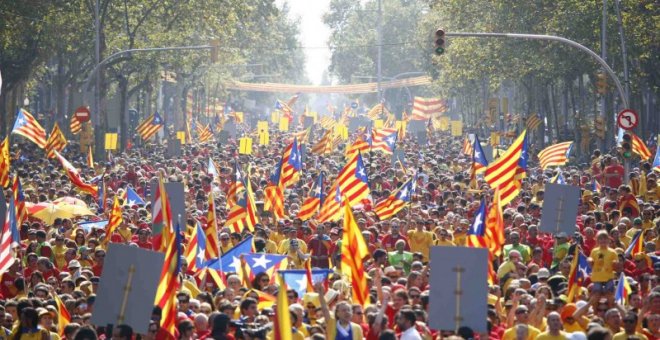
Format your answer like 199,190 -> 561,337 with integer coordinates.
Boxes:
341,204 -> 369,306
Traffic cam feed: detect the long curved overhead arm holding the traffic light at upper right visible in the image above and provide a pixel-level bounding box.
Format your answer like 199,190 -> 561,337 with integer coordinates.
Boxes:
445,32 -> 630,109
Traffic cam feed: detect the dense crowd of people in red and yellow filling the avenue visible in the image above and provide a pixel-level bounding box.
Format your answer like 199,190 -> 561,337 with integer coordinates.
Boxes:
0,121 -> 660,340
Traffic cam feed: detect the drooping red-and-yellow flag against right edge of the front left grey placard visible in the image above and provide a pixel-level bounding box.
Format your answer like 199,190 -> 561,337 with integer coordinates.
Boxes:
154,219 -> 182,339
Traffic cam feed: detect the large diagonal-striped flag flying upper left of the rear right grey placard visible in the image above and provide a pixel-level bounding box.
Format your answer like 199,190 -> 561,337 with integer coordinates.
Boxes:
484,130 -> 527,205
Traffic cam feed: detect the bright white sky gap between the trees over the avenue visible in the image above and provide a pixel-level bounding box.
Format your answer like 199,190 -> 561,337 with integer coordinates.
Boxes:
277,0 -> 330,85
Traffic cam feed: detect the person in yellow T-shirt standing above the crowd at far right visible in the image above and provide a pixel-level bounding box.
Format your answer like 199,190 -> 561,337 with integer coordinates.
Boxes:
589,230 -> 619,296
